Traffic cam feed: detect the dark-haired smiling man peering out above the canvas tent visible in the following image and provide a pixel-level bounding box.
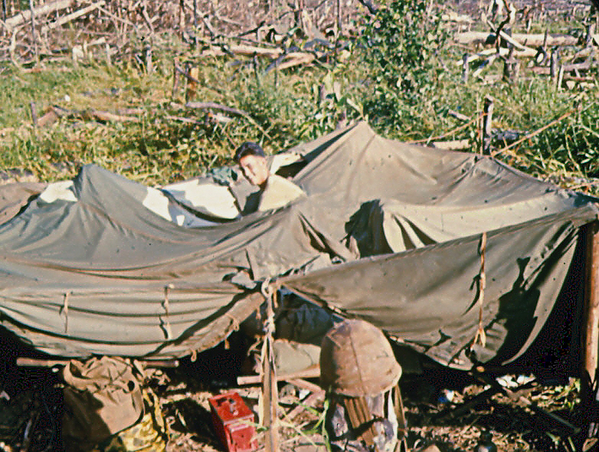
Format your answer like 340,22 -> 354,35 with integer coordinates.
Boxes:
235,141 -> 306,212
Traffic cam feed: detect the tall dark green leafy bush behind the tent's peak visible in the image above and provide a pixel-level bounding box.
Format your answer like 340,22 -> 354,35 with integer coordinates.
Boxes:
360,0 -> 448,134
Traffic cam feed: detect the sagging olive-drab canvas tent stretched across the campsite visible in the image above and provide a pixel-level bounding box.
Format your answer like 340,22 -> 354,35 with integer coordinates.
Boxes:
0,123 -> 597,368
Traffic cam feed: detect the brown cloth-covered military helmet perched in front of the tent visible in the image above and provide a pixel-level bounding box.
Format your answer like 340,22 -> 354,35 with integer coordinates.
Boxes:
320,320 -> 401,397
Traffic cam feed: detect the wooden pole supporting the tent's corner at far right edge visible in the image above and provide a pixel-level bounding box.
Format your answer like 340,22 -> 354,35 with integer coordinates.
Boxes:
581,221 -> 599,423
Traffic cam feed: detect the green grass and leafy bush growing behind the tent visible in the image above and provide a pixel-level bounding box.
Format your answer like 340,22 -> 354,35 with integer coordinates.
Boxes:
0,0 -> 599,192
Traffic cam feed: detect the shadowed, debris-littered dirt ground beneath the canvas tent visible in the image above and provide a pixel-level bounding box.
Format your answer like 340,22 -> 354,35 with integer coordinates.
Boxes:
0,328 -> 592,452
